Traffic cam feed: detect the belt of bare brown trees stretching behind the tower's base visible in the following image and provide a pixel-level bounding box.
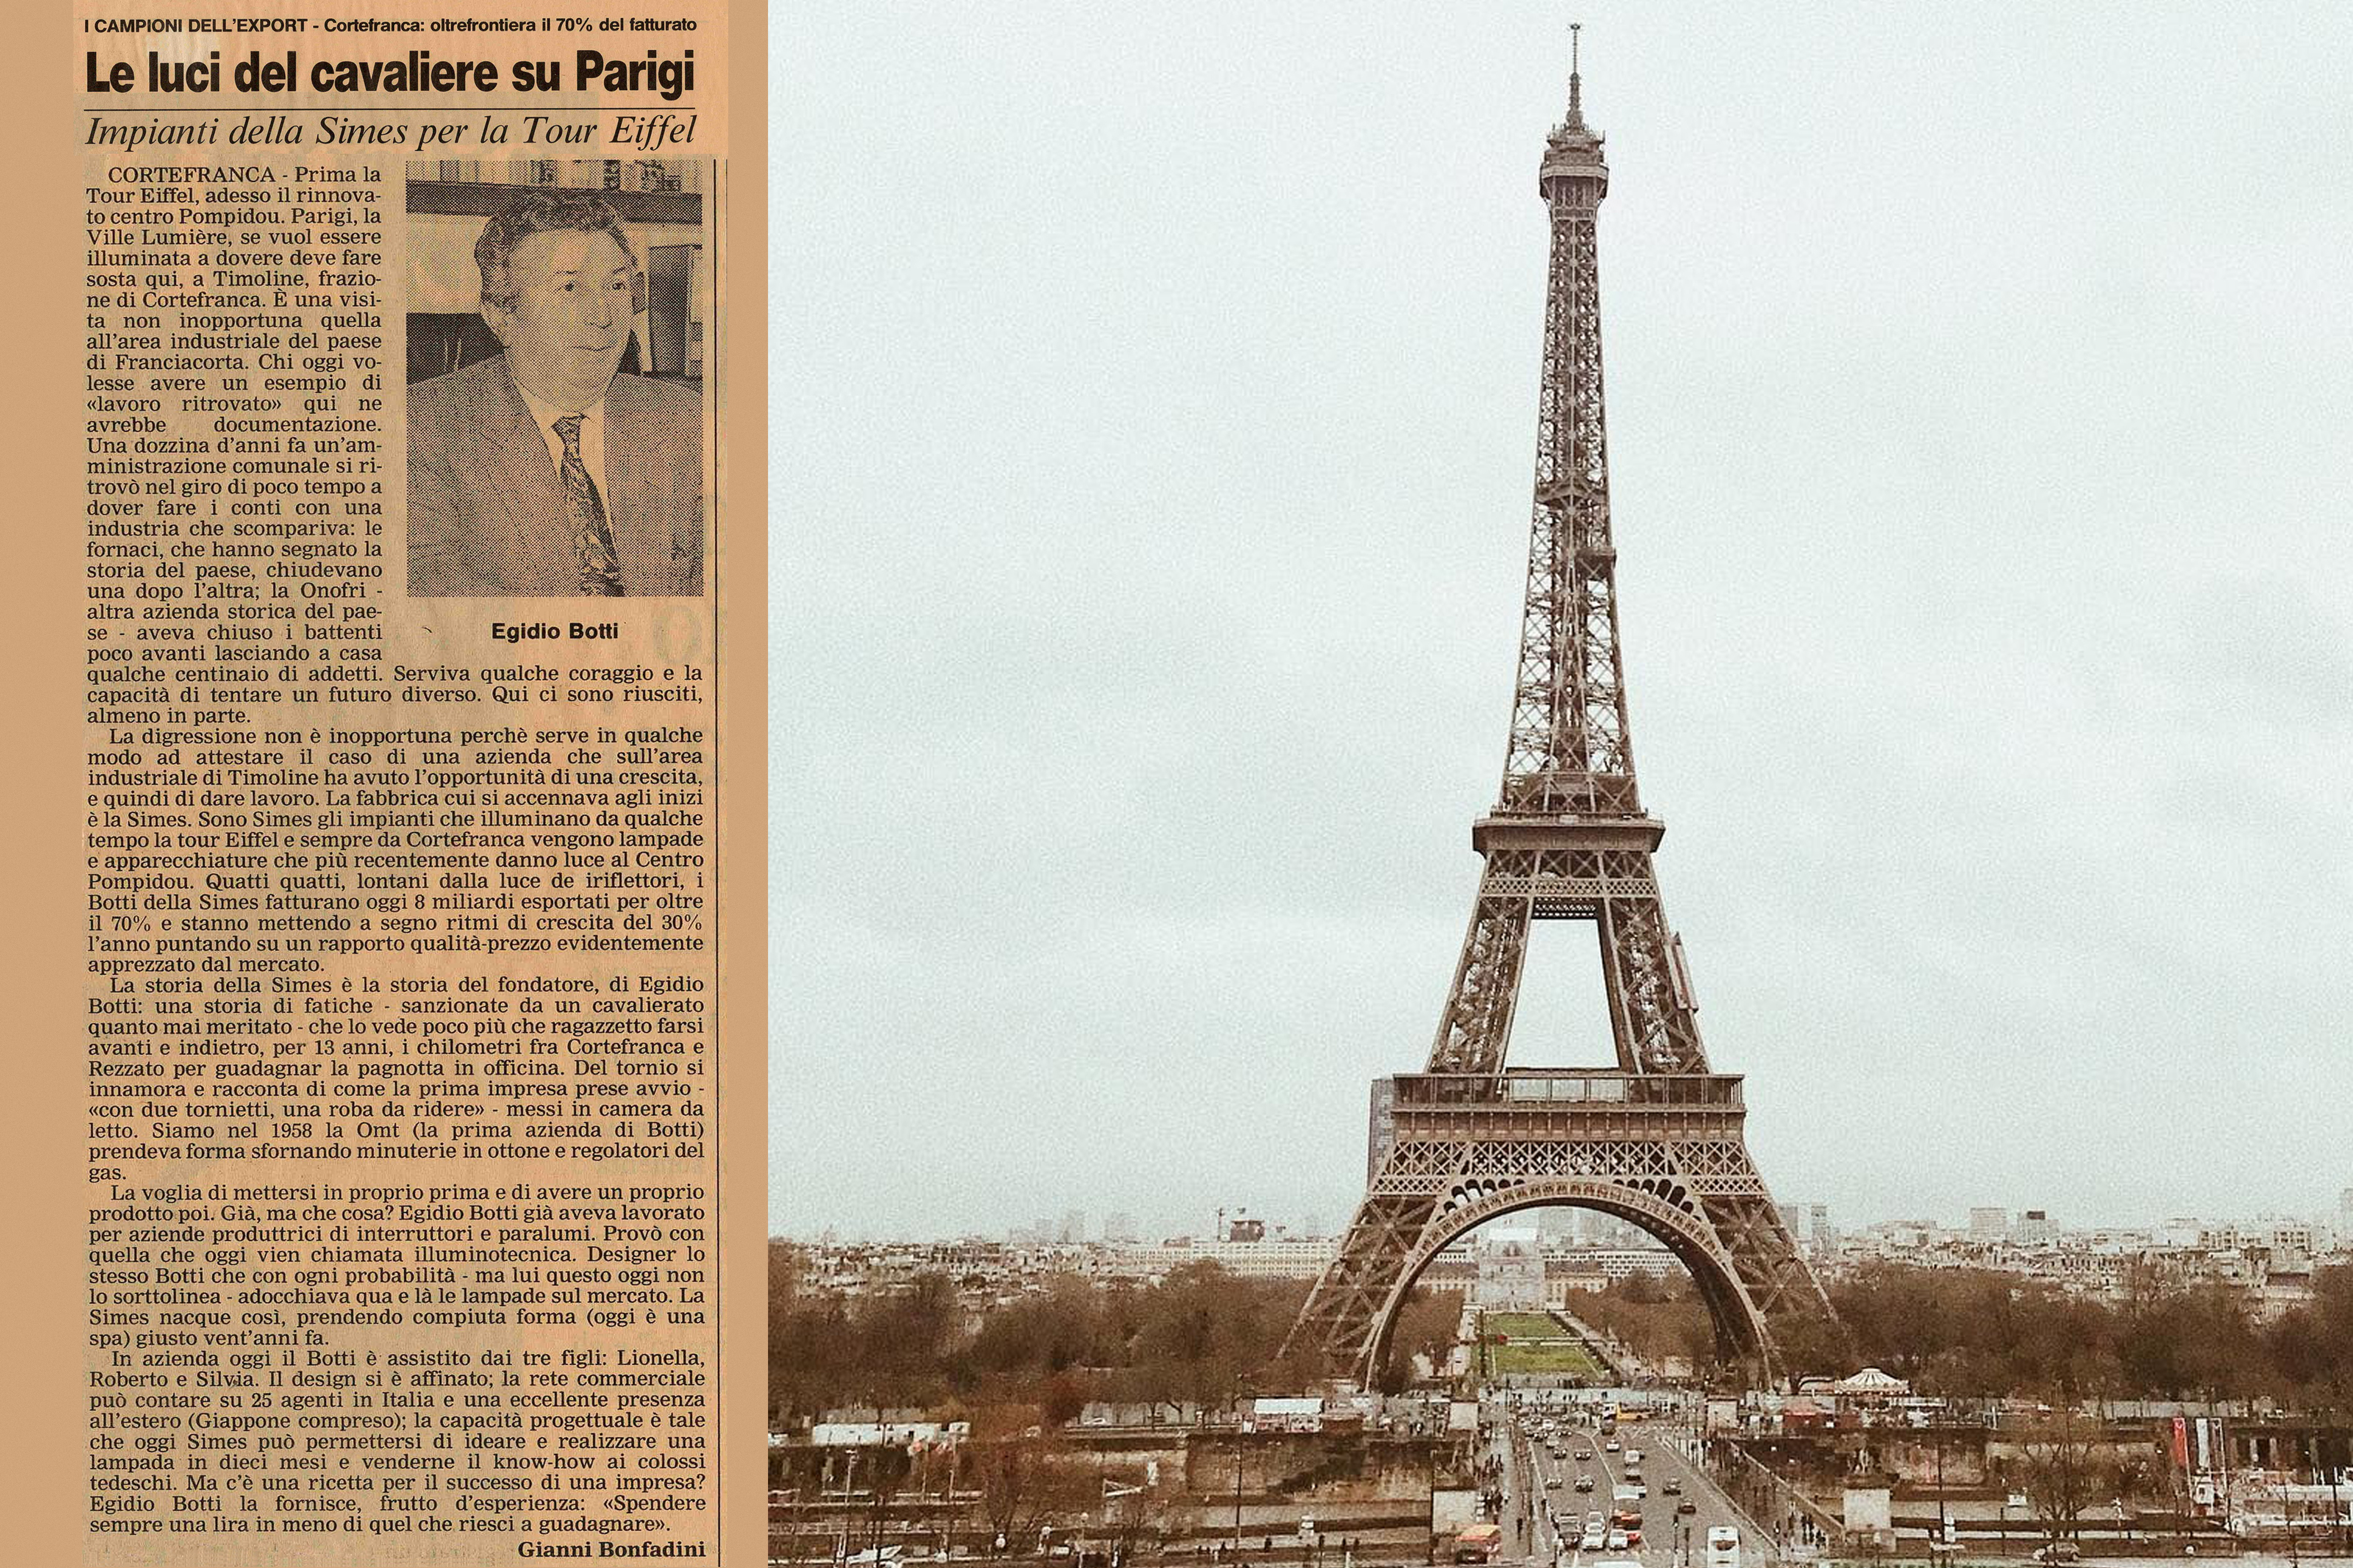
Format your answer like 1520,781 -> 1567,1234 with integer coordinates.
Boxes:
770,1246 -> 2353,1425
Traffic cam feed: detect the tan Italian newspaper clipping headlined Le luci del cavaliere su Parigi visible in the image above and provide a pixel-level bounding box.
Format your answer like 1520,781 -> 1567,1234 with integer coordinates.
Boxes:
54,0 -> 762,1563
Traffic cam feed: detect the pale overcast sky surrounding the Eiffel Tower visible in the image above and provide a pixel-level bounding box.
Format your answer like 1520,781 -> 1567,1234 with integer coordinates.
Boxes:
770,0 -> 2353,1237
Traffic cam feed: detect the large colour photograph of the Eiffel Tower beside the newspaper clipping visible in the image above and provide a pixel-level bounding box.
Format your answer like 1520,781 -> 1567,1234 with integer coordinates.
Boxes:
767,5 -> 2353,1568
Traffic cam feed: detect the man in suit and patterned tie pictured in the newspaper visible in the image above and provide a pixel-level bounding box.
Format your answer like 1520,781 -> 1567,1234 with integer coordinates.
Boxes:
409,191 -> 703,599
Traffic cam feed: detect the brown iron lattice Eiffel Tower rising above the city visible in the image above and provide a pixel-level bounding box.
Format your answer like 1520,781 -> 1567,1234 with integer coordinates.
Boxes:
1285,40 -> 1835,1382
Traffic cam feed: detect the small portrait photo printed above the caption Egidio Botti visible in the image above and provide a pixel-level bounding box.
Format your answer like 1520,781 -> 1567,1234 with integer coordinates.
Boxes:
407,157 -> 711,597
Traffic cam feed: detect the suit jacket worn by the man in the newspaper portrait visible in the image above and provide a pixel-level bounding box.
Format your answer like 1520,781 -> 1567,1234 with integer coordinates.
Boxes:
409,355 -> 703,599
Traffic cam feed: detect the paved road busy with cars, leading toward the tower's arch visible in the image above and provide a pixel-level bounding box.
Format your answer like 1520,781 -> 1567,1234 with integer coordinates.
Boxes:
1504,1415 -> 1765,1568
